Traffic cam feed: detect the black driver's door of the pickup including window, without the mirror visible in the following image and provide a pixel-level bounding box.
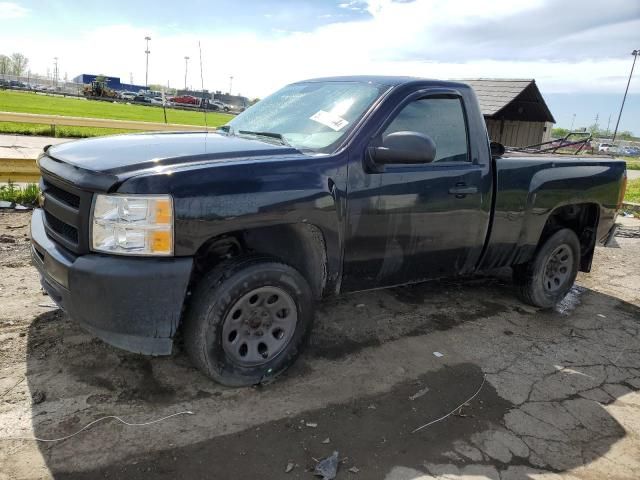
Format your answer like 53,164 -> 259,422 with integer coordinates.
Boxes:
342,93 -> 490,291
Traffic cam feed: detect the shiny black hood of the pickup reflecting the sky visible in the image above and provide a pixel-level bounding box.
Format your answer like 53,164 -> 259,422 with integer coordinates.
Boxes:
46,132 -> 300,176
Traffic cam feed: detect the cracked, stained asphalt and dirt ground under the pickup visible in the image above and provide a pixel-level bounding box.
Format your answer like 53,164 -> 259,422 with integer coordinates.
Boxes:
0,214 -> 640,480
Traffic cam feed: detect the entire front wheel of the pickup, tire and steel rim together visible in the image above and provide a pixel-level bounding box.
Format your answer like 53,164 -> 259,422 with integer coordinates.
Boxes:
184,256 -> 313,386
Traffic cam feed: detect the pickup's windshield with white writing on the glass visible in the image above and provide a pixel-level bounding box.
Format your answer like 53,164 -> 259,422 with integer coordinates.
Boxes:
222,81 -> 381,153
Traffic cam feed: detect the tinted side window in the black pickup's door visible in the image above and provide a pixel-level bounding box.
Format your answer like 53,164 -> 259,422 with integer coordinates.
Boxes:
382,98 -> 469,162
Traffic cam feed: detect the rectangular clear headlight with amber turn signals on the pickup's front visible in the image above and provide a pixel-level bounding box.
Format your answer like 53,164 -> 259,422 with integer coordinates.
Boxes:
91,195 -> 173,256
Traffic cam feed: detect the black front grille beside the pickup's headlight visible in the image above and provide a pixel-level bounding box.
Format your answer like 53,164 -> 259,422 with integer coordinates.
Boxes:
41,170 -> 93,254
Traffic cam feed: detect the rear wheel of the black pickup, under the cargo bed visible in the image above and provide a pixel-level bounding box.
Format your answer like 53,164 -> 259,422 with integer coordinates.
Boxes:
513,228 -> 580,308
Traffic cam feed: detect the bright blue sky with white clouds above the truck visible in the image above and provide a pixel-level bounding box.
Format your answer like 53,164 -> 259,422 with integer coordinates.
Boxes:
0,0 -> 640,135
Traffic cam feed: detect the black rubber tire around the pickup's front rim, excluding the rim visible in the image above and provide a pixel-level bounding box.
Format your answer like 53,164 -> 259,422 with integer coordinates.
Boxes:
184,256 -> 314,387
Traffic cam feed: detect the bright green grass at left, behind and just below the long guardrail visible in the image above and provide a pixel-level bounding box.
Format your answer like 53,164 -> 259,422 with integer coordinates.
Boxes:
0,90 -> 233,137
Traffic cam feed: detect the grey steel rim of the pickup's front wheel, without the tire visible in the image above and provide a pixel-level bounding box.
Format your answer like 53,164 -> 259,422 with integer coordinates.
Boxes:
222,286 -> 298,367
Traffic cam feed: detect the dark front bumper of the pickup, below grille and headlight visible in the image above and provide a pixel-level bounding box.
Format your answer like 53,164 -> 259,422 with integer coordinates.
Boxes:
31,209 -> 193,355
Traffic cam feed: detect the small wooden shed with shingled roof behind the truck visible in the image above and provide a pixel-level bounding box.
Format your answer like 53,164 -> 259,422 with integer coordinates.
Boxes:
462,78 -> 556,147
